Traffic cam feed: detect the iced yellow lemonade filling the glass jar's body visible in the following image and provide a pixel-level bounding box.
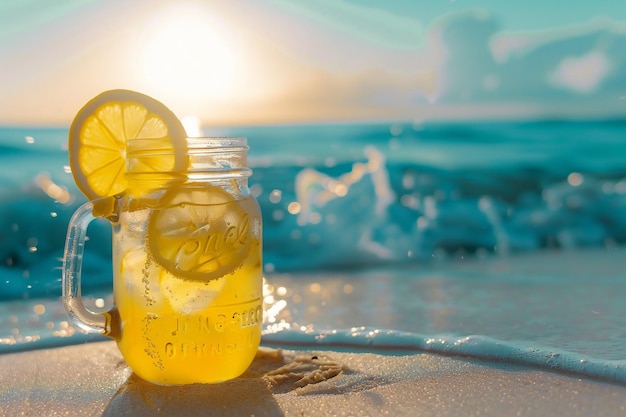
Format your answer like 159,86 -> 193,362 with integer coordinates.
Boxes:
113,189 -> 263,384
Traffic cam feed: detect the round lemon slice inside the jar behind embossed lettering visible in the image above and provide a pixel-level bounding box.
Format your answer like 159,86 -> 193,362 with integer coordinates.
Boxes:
147,186 -> 254,282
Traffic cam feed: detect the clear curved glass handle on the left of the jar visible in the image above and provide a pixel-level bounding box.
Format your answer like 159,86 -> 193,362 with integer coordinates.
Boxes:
63,201 -> 111,335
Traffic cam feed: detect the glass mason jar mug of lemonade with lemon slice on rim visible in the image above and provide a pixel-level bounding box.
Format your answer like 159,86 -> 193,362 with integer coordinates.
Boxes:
63,90 -> 263,385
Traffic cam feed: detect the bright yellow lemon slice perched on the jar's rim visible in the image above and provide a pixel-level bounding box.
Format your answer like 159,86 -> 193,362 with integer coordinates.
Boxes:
69,90 -> 187,200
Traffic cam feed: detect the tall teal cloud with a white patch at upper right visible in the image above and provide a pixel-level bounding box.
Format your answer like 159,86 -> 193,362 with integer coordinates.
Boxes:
432,11 -> 626,108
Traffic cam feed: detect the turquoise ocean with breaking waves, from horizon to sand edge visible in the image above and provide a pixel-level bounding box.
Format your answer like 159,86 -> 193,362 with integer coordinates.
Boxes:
0,120 -> 626,383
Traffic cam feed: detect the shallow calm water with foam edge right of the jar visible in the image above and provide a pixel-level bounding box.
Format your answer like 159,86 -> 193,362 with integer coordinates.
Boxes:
265,248 -> 626,383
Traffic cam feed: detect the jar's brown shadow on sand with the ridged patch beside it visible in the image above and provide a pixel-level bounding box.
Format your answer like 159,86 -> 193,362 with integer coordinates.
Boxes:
102,349 -> 344,417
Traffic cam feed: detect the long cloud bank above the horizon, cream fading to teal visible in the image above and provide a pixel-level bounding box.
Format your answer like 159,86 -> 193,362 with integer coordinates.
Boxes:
232,10 -> 626,120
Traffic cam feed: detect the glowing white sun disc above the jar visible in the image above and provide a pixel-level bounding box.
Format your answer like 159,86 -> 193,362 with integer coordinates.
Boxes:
141,4 -> 239,99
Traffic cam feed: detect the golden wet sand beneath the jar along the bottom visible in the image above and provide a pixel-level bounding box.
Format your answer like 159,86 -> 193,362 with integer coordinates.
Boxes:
0,342 -> 626,416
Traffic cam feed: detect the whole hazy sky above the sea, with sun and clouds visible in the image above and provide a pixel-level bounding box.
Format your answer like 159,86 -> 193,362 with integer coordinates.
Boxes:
0,0 -> 626,126
